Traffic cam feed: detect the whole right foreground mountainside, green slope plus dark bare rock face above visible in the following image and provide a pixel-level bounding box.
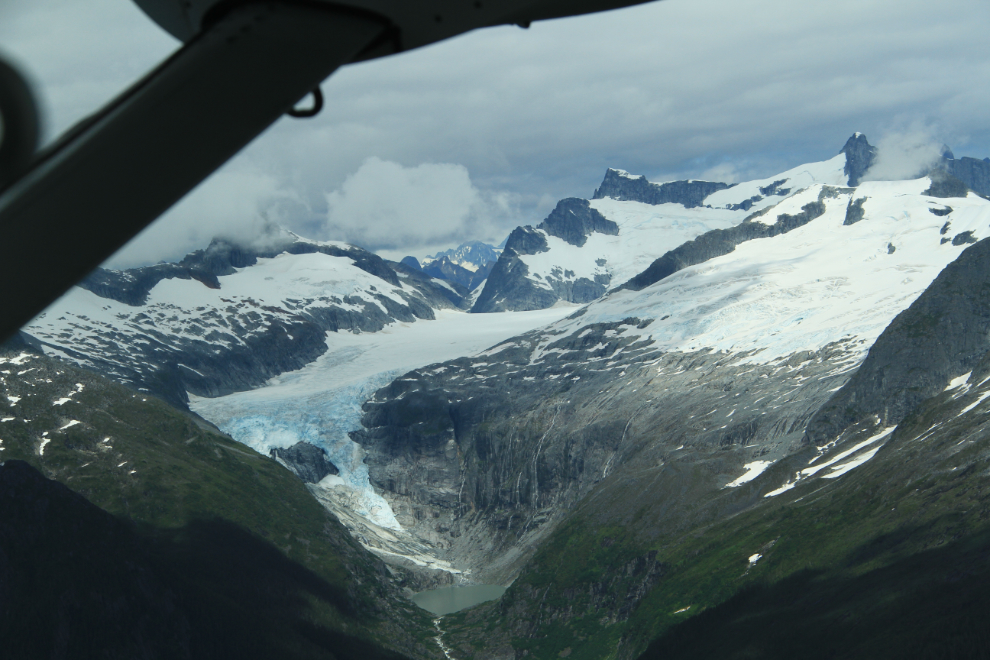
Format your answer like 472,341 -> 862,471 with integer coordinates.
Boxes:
445,241 -> 990,660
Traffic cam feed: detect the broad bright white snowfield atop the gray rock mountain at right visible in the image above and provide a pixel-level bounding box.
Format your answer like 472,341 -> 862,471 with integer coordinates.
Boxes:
546,178 -> 990,362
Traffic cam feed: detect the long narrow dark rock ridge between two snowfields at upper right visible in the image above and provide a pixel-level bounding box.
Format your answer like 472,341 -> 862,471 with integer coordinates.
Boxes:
620,195 -> 825,291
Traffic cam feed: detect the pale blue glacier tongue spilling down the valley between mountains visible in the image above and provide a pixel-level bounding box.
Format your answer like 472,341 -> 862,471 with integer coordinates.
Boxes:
189,304 -> 577,540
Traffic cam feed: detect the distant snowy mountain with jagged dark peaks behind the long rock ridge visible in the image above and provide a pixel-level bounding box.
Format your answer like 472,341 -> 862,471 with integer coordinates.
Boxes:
472,133 -> 990,312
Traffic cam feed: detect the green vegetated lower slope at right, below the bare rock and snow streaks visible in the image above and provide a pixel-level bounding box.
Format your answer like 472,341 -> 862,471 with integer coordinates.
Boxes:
445,360 -> 990,660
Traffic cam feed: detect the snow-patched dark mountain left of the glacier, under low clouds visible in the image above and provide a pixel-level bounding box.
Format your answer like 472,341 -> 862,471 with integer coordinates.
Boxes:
23,232 -> 467,406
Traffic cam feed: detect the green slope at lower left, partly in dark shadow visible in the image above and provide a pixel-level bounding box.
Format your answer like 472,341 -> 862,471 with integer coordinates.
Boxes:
0,351 -> 436,659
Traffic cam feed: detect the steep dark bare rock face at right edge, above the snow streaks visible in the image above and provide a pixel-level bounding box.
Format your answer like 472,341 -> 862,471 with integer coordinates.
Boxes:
806,239 -> 990,444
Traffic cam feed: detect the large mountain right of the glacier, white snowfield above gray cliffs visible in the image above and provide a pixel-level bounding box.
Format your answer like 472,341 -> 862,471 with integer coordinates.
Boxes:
352,169 -> 990,581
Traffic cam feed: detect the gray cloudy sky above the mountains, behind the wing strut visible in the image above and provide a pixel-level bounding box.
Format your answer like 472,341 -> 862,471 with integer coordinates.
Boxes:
0,0 -> 990,267
